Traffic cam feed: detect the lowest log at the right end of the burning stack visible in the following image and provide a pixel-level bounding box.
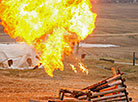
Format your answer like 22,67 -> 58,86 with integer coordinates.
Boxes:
91,93 -> 125,102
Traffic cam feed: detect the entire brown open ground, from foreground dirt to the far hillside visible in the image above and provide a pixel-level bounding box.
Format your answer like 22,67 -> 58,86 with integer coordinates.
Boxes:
0,4 -> 138,102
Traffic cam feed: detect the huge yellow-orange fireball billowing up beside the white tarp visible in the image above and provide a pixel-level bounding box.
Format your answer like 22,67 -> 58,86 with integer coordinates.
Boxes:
0,0 -> 96,77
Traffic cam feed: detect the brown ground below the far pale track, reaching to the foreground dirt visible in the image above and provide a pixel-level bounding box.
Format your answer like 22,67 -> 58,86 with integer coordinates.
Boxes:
0,35 -> 138,102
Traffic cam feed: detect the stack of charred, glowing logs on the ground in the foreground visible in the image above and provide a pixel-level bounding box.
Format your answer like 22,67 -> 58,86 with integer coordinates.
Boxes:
59,68 -> 132,102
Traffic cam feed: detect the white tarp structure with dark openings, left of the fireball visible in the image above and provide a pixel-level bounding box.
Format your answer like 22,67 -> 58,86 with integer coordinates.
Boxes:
0,43 -> 38,69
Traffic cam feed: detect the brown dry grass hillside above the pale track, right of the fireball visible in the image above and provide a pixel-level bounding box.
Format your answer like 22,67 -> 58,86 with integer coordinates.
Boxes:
93,3 -> 138,34
